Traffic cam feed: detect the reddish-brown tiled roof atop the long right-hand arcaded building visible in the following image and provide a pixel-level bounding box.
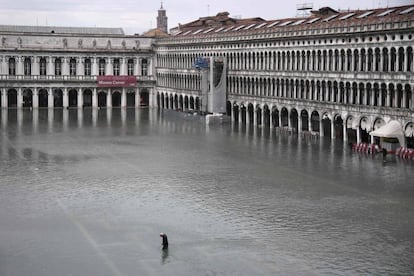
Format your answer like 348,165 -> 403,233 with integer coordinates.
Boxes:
171,5 -> 414,38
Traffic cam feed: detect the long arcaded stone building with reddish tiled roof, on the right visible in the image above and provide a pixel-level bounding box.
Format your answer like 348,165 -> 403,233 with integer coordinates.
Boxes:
155,6 -> 414,147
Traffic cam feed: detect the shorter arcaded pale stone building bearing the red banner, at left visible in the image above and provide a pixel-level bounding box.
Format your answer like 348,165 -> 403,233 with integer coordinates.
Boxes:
0,26 -> 155,108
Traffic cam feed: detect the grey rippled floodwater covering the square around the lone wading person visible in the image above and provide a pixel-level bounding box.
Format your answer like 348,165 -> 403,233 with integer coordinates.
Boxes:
0,109 -> 414,276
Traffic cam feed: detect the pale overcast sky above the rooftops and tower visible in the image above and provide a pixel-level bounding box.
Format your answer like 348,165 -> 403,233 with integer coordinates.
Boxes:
0,0 -> 414,34
